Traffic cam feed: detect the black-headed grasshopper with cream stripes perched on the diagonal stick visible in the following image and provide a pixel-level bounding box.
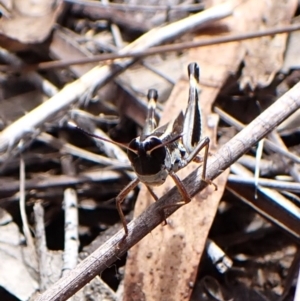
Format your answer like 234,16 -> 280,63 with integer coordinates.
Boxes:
75,63 -> 212,237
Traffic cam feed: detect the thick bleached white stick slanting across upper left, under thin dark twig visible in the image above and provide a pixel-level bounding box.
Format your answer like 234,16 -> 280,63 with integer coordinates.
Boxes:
0,3 -> 234,159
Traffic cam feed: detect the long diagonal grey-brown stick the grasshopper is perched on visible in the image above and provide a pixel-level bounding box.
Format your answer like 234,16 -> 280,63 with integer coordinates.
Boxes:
38,74 -> 300,301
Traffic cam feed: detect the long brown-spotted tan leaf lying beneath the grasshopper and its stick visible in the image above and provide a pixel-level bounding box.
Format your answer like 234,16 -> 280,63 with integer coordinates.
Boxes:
120,3 -> 254,300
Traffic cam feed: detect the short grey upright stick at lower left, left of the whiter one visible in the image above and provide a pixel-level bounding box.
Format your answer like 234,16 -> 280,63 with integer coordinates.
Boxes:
33,201 -> 49,292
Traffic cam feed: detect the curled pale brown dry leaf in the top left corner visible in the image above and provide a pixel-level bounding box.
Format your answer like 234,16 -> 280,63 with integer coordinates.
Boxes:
0,0 -> 62,51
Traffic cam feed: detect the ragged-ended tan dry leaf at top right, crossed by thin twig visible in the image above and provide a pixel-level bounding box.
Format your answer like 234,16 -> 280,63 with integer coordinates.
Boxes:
237,0 -> 298,90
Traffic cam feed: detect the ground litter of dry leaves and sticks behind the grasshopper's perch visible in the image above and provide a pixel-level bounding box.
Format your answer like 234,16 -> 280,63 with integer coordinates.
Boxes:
0,0 -> 300,300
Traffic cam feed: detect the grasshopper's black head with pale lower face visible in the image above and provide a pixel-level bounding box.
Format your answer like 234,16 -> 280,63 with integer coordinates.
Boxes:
128,135 -> 168,185
